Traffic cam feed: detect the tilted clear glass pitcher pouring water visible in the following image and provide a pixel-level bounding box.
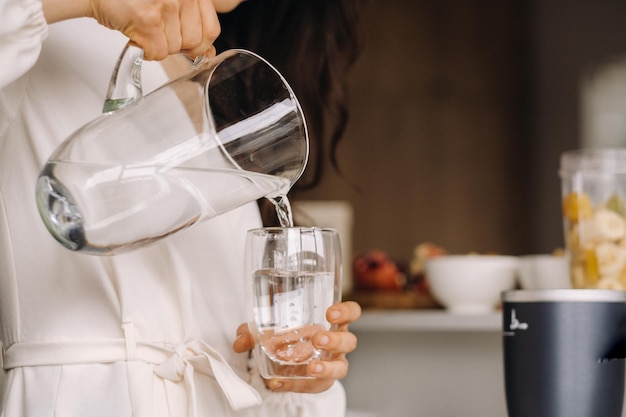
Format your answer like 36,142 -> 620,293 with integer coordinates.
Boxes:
36,45 -> 309,255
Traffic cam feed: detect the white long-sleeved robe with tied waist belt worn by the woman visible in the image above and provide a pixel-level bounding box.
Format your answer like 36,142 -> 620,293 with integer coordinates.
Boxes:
0,0 -> 345,417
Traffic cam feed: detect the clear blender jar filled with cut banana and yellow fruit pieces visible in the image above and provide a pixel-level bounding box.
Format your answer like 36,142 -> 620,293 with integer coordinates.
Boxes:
560,149 -> 626,290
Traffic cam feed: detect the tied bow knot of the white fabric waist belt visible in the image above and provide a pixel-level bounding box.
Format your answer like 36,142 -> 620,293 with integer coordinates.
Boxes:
154,340 -> 262,417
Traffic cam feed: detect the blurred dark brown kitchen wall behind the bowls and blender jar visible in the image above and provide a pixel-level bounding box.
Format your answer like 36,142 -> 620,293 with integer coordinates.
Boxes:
295,0 -> 626,261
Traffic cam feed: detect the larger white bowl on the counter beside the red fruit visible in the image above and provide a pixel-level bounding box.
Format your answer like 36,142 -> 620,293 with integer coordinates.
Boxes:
426,255 -> 518,314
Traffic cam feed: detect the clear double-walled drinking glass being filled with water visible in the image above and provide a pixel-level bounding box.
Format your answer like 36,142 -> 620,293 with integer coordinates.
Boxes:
245,227 -> 342,378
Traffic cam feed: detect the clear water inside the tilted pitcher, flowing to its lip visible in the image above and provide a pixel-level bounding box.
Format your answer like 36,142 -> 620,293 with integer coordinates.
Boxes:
37,161 -> 292,255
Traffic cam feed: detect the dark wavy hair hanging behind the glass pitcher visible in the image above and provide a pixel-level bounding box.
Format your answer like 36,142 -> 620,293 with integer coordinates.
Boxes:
215,0 -> 366,192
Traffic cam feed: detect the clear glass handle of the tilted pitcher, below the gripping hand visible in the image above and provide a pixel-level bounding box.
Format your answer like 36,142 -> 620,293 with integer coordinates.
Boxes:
102,42 -> 143,113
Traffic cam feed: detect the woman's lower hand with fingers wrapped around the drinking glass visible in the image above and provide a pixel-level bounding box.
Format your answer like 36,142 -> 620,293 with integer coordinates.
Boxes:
233,301 -> 361,393
